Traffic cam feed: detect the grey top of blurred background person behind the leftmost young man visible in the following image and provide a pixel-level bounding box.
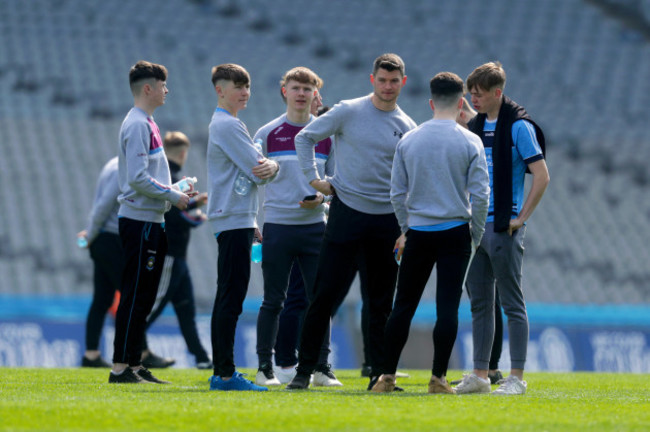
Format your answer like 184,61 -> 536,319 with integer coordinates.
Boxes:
86,156 -> 120,244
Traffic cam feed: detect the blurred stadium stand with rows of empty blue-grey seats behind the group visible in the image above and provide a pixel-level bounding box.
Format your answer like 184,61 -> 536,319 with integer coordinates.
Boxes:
0,0 -> 650,311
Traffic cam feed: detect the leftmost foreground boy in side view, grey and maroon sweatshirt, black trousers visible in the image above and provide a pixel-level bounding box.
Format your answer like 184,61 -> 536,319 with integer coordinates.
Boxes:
108,61 -> 190,383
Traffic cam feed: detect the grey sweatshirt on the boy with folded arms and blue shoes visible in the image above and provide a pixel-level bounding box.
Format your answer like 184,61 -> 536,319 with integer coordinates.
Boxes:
207,108 -> 279,233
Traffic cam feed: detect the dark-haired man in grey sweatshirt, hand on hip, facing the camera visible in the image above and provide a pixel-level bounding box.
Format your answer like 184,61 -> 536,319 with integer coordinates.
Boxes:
287,54 -> 416,389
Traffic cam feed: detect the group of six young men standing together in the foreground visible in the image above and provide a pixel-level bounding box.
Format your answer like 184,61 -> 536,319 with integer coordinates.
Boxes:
90,54 -> 549,394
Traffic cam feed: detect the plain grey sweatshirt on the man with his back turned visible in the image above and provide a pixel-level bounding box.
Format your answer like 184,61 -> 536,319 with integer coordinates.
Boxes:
390,119 -> 490,245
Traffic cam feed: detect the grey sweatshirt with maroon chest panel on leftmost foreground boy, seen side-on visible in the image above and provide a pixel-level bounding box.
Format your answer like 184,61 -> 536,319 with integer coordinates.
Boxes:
118,107 -> 182,223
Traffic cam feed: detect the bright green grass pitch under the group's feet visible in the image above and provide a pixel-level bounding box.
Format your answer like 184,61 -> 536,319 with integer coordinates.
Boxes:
0,368 -> 650,432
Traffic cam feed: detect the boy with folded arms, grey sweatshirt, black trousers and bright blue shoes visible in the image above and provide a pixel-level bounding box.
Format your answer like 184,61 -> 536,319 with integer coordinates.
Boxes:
207,63 -> 279,391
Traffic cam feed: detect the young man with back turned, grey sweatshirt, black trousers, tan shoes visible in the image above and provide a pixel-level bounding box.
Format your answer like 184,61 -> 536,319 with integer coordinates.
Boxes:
372,72 -> 490,393
